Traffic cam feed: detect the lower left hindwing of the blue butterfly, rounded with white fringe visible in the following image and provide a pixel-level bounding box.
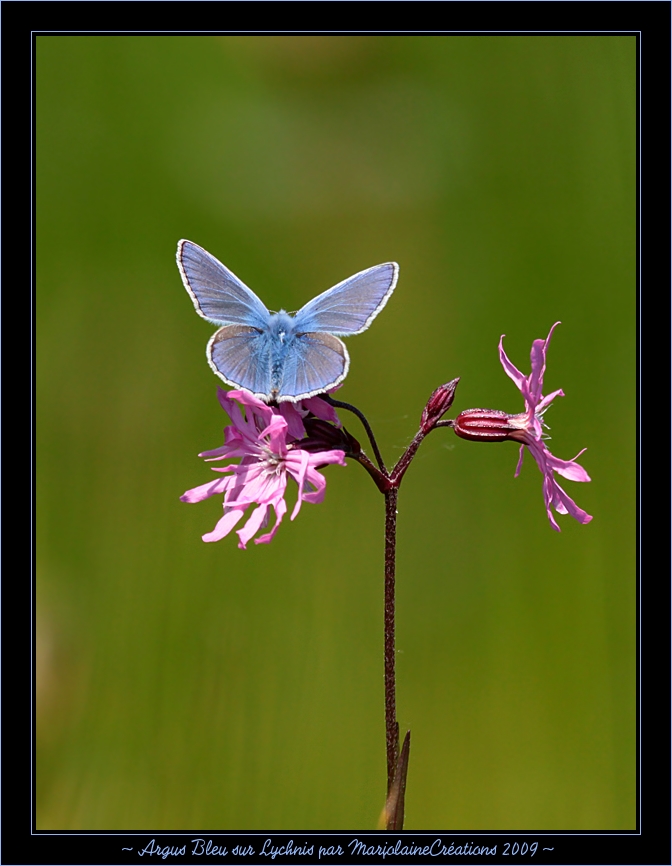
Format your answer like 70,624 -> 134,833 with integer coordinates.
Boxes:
207,325 -> 272,400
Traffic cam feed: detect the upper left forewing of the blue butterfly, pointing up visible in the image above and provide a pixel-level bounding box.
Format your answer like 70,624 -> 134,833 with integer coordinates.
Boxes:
177,240 -> 271,329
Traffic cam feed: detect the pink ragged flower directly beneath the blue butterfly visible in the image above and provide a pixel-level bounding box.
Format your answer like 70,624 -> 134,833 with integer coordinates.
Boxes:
180,388 -> 345,550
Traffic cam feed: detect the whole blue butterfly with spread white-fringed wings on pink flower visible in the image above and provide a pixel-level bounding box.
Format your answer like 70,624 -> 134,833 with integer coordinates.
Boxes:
177,240 -> 399,403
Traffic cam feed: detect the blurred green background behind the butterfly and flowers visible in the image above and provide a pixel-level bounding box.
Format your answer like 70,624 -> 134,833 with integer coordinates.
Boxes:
36,36 -> 636,830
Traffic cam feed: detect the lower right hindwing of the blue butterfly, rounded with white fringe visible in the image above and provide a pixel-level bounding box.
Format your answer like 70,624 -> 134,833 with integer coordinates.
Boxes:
278,332 -> 350,402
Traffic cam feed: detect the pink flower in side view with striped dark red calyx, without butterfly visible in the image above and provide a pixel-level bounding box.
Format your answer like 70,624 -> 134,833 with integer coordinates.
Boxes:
454,322 -> 593,532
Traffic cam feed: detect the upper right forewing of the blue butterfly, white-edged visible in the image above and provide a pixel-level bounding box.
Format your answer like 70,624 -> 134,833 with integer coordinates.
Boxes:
295,262 -> 399,337
